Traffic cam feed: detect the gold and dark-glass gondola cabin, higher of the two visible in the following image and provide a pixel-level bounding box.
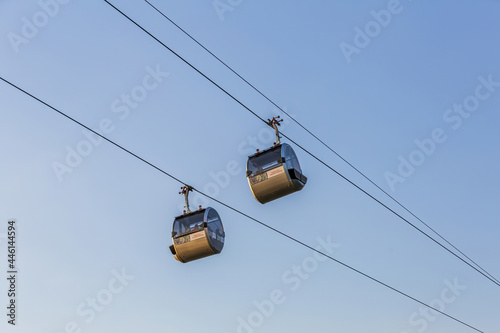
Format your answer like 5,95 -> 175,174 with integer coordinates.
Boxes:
247,143 -> 307,204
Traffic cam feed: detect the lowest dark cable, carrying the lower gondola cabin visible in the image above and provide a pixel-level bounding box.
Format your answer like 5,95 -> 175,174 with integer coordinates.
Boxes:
0,76 -> 485,333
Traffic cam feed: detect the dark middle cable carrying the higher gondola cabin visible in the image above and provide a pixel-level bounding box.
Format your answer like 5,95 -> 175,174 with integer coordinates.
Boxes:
104,0 -> 500,286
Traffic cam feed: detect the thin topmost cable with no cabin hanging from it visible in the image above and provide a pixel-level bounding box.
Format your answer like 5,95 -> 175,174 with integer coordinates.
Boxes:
144,0 -> 500,283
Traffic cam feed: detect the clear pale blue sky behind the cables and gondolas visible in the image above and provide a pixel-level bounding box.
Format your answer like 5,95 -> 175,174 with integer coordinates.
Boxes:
0,0 -> 500,333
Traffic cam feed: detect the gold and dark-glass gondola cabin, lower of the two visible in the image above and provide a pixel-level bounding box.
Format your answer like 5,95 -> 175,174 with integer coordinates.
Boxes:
170,207 -> 225,263
